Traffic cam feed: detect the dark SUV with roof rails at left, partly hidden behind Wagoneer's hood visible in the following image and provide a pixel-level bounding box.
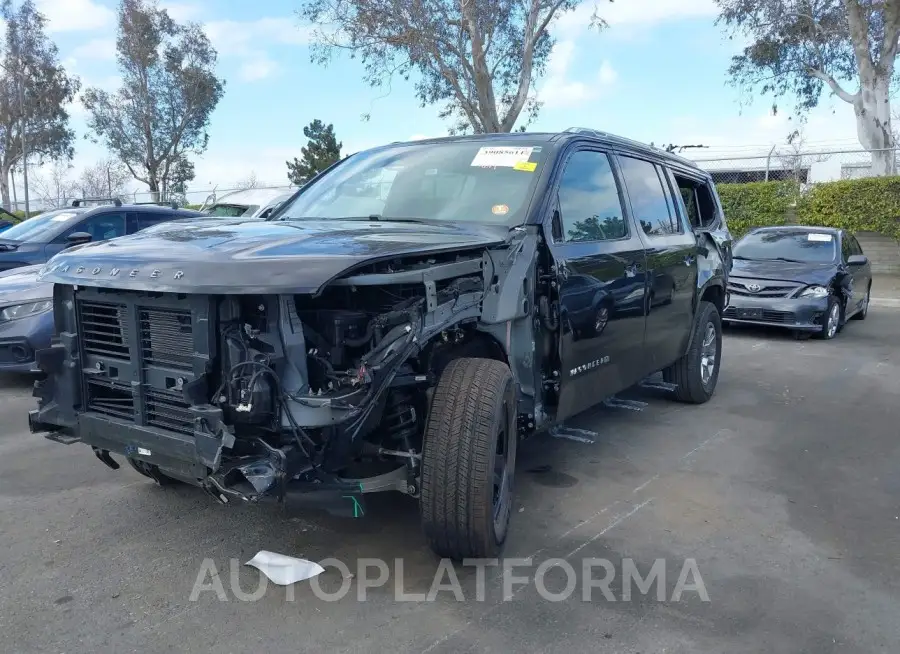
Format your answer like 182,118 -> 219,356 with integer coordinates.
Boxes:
0,198 -> 203,271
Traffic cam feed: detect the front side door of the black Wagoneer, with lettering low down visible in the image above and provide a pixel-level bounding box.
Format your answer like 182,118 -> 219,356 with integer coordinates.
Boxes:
550,149 -> 646,419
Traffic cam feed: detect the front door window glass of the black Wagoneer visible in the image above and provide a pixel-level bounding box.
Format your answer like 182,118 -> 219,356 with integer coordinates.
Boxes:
559,150 -> 628,242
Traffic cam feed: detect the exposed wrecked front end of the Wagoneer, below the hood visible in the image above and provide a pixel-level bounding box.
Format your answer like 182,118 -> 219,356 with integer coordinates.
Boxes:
29,251 -> 489,515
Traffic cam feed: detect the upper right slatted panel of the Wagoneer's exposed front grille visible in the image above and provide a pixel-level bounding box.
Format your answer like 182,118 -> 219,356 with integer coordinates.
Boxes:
139,308 -> 194,372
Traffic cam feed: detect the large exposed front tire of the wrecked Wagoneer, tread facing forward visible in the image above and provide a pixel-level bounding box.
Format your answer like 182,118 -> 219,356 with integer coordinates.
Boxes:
420,358 -> 518,560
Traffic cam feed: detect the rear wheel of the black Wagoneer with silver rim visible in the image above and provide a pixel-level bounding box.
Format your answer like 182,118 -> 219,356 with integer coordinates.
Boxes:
663,302 -> 722,404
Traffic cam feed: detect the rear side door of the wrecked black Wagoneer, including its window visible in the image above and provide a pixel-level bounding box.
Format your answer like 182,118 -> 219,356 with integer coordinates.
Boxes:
617,154 -> 697,372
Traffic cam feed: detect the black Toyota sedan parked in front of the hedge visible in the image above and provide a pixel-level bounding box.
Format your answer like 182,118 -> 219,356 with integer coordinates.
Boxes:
722,227 -> 872,339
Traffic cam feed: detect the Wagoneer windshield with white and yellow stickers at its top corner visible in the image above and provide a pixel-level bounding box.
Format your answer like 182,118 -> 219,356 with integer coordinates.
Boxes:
276,140 -> 543,225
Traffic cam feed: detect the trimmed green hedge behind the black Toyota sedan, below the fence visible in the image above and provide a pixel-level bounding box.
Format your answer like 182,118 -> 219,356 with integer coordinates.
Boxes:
716,177 -> 900,238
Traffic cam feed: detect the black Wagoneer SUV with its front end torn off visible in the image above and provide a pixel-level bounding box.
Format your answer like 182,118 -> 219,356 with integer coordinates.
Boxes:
29,128 -> 731,558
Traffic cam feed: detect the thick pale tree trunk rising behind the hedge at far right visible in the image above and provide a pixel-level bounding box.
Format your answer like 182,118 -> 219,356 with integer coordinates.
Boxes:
853,74 -> 897,177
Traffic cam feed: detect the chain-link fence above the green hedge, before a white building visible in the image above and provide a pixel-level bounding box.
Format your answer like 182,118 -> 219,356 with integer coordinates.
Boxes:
690,147 -> 900,185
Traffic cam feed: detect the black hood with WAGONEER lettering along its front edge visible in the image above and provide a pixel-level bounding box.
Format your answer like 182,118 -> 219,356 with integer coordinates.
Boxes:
40,218 -> 507,294
